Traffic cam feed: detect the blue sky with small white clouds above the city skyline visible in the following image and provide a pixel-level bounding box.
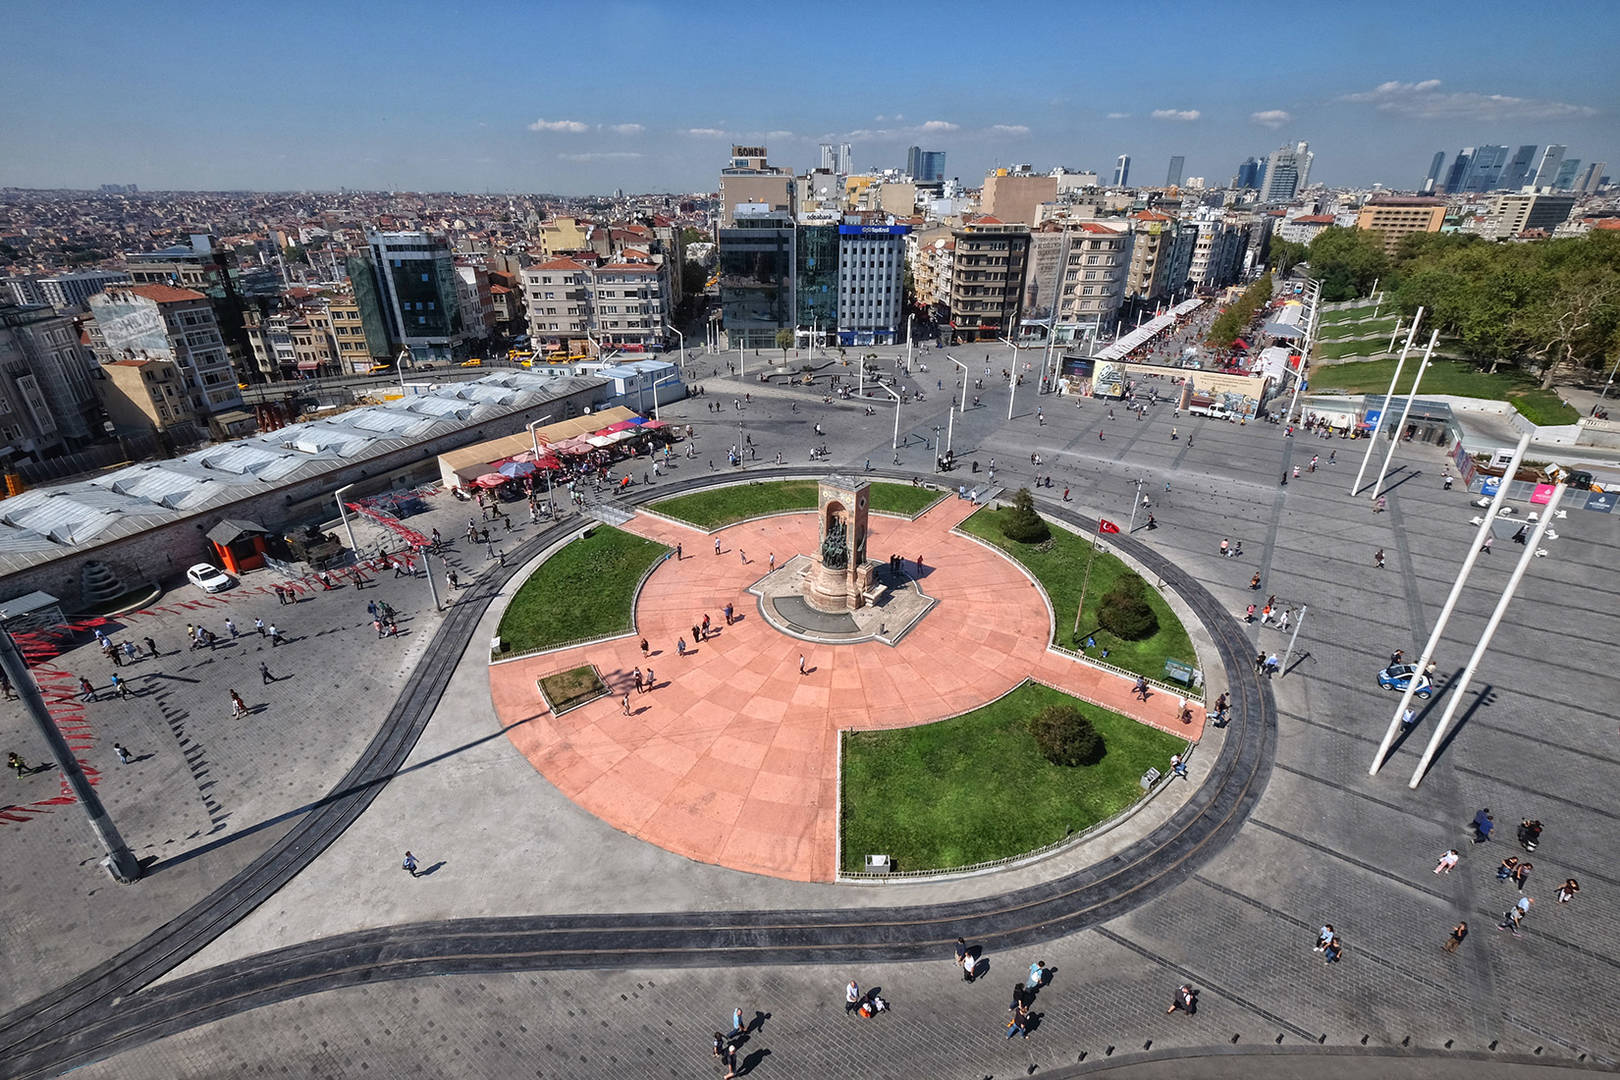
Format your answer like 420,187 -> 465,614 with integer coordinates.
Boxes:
0,0 -> 1620,194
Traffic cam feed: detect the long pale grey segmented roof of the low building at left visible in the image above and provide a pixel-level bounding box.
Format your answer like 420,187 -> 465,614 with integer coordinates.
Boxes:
0,371 -> 601,573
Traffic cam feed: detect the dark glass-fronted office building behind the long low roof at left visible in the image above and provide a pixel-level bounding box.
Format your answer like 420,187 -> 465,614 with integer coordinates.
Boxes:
348,232 -> 467,364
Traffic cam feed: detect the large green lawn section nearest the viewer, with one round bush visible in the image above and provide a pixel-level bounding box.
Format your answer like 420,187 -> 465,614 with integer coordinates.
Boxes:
839,683 -> 1186,870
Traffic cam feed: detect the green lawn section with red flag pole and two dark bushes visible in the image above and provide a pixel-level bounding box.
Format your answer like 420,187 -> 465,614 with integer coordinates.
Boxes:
961,507 -> 1197,678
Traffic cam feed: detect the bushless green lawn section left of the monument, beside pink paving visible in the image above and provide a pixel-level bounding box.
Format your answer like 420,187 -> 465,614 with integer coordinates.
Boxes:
497,525 -> 669,653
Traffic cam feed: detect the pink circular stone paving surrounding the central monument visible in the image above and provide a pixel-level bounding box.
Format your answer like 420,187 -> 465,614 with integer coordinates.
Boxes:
489,499 -> 1202,881
